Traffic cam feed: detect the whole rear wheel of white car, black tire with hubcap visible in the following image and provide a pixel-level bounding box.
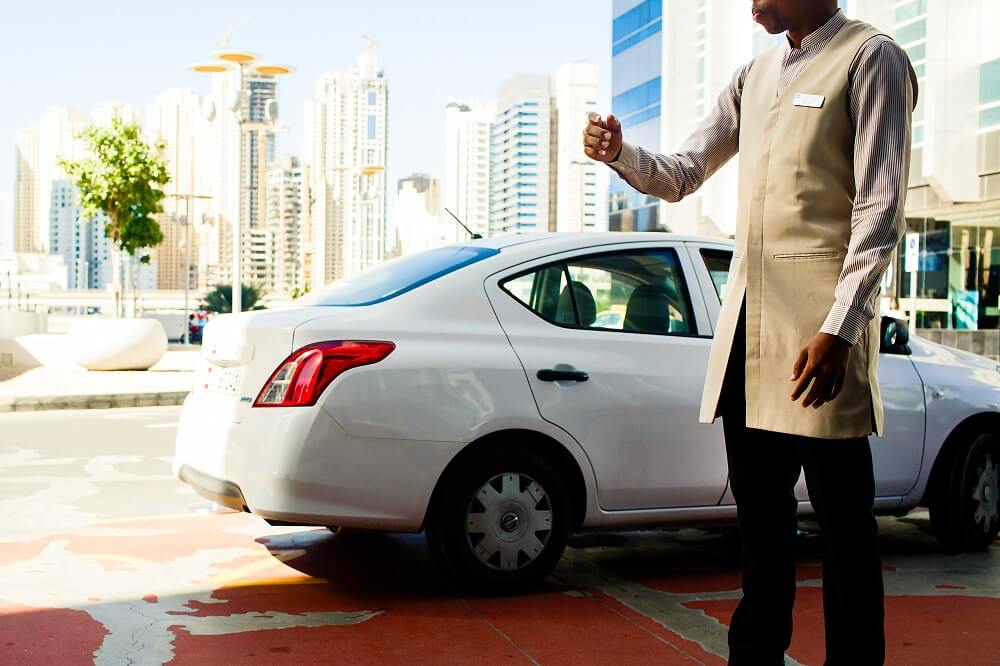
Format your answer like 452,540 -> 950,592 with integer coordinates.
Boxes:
426,448 -> 572,594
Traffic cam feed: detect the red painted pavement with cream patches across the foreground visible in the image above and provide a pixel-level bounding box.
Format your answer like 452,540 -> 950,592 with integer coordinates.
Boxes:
0,515 -> 1000,665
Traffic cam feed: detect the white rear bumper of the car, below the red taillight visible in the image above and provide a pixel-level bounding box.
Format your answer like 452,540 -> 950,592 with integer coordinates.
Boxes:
174,391 -> 463,532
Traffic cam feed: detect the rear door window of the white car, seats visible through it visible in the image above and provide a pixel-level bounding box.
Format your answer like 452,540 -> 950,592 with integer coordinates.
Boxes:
503,249 -> 697,335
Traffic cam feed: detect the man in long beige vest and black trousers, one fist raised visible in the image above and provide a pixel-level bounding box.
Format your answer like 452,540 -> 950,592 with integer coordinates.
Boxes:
584,0 -> 916,664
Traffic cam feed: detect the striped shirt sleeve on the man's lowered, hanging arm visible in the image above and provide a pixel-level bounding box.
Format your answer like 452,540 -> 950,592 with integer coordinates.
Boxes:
820,38 -> 916,345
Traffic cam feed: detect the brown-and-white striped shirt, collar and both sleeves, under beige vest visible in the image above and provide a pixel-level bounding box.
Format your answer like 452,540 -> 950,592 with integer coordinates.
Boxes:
608,10 -> 916,345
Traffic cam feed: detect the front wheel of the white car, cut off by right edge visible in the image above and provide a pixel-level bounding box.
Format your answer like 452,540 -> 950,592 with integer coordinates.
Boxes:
929,432 -> 1000,551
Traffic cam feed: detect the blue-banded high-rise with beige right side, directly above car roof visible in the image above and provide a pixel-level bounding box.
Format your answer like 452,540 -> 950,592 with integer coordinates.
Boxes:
489,75 -> 555,236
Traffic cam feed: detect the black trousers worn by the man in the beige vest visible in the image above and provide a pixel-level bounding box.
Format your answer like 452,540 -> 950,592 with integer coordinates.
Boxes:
720,301 -> 885,666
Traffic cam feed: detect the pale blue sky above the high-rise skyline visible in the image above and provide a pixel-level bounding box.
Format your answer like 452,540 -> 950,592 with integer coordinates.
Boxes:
0,0 -> 611,244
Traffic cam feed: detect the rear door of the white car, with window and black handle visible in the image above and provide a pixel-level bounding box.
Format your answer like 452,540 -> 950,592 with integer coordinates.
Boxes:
486,243 -> 727,510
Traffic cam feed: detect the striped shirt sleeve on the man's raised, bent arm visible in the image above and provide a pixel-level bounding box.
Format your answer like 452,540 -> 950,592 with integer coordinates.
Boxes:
608,63 -> 751,202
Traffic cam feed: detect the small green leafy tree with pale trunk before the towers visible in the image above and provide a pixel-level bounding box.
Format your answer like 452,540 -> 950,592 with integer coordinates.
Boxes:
59,118 -> 170,317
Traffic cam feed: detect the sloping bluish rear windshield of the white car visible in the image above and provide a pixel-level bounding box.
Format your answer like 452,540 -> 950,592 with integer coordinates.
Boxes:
298,245 -> 499,305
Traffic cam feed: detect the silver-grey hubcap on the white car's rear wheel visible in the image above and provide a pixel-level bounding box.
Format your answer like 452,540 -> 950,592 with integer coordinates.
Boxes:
465,472 -> 552,571
